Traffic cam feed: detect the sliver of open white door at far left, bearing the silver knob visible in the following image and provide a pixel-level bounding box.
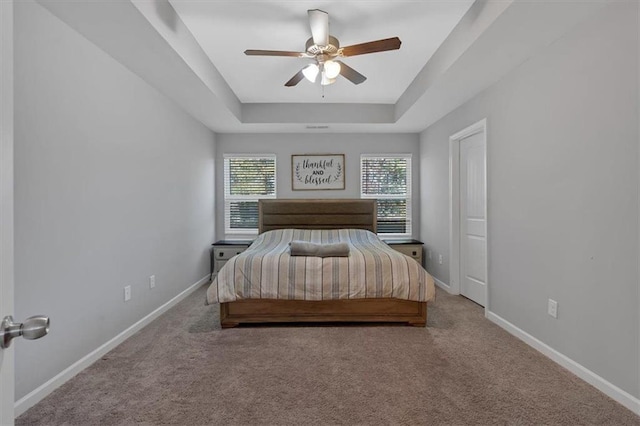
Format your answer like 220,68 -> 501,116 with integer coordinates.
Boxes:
0,0 -> 15,425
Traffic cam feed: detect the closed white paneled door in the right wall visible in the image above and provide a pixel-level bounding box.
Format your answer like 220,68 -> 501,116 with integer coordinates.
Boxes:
460,132 -> 487,306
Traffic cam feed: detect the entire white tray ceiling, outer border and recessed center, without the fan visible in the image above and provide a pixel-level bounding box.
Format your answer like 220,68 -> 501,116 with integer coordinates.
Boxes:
36,0 -> 610,133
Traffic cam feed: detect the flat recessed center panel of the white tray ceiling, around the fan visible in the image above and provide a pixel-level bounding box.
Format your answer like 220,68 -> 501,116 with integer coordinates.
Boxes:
169,0 -> 473,104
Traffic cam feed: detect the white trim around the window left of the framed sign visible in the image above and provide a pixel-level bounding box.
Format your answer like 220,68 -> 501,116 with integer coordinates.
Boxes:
222,153 -> 278,239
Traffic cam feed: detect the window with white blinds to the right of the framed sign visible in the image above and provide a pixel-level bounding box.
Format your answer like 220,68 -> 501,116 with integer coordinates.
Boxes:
360,154 -> 411,236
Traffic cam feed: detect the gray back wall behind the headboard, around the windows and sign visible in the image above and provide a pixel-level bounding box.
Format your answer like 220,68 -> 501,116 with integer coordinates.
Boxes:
216,133 -> 420,237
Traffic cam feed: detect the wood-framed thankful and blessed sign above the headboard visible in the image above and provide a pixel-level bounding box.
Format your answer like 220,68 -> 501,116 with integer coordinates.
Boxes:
291,154 -> 344,191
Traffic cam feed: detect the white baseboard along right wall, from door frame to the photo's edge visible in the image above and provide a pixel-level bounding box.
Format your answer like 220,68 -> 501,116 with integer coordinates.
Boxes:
486,312 -> 640,415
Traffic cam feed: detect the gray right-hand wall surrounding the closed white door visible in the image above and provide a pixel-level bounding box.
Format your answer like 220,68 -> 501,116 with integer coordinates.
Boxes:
420,2 -> 640,397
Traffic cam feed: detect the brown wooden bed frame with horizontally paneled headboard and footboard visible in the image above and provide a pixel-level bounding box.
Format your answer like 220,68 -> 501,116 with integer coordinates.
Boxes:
220,199 -> 427,328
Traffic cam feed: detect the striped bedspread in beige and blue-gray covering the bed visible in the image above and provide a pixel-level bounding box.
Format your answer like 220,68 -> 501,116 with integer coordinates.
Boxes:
207,229 -> 435,303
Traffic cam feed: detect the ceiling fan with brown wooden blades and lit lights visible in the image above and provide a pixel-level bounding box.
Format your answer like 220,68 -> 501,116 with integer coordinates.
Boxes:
244,9 -> 402,87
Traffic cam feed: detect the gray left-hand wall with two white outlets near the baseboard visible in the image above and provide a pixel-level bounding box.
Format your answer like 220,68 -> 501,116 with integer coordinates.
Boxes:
15,2 -> 215,398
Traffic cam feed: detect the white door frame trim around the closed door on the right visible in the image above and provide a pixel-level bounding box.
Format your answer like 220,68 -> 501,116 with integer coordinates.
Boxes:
449,118 -> 490,317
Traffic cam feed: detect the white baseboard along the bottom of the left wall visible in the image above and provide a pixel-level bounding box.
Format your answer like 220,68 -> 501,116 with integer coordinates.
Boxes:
14,274 -> 209,417
